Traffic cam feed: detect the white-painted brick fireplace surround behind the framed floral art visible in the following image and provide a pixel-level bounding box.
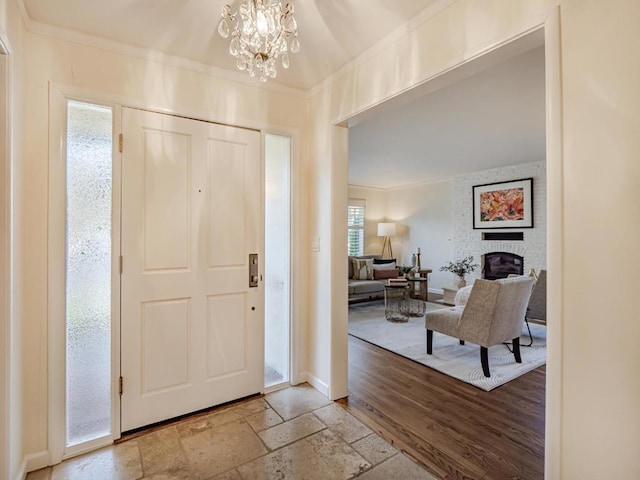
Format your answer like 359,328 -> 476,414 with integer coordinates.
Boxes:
452,161 -> 547,283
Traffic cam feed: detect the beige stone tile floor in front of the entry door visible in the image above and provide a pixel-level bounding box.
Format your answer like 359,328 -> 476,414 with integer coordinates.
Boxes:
27,385 -> 435,480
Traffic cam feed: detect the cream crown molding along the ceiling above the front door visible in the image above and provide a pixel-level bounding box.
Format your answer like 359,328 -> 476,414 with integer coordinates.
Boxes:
16,0 -> 309,98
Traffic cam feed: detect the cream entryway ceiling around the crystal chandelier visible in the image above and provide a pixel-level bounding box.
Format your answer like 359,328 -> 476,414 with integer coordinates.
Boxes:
18,0 -> 440,91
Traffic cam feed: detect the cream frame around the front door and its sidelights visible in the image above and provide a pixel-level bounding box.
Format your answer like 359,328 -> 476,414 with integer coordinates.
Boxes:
47,82 -> 308,462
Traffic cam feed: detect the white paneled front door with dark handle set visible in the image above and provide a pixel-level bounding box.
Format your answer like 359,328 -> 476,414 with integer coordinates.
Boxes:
121,108 -> 264,431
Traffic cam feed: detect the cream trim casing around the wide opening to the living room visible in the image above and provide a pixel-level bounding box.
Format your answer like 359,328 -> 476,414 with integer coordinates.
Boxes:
330,5 -> 564,478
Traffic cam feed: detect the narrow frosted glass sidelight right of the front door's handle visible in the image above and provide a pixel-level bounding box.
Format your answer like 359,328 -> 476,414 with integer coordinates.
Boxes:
264,135 -> 291,387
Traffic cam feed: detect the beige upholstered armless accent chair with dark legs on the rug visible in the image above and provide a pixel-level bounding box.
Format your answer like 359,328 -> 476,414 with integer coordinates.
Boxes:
425,276 -> 533,377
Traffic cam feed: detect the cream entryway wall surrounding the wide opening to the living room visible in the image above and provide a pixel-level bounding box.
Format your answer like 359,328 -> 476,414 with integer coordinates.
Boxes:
309,0 -> 640,480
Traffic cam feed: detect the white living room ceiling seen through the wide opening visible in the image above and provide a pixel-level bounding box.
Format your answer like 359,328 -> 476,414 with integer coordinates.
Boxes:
349,47 -> 545,188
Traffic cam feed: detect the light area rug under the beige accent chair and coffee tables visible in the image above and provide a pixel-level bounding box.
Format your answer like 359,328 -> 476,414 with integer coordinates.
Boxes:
349,302 -> 547,391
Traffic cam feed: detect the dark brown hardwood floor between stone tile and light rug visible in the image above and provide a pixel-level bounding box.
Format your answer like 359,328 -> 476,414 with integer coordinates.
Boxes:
339,336 -> 545,480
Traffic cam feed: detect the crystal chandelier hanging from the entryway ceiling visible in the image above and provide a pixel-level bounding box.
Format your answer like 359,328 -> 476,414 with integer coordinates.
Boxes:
218,0 -> 300,82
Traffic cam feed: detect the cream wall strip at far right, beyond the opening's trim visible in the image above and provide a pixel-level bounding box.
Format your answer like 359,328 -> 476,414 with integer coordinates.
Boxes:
558,1 -> 640,480
